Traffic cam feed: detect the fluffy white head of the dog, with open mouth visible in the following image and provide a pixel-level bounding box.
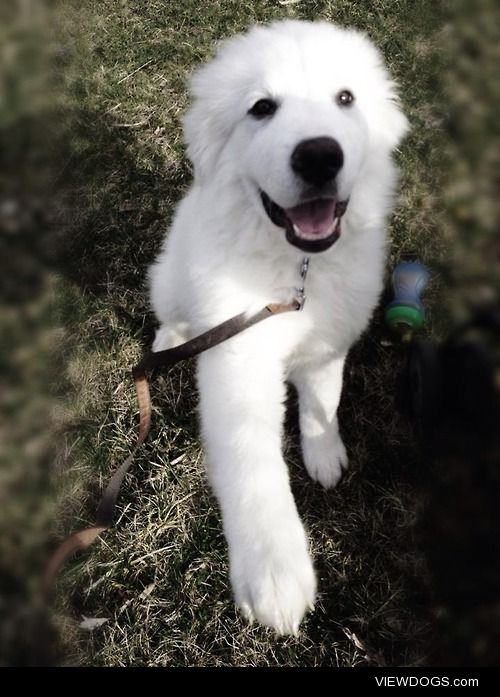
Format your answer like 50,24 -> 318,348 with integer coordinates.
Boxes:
185,21 -> 407,252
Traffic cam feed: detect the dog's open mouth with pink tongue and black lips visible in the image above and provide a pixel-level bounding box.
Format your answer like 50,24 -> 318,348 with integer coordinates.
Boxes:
260,191 -> 348,252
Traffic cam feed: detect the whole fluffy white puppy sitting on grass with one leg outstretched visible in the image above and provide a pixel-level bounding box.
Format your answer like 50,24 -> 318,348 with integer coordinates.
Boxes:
150,21 -> 407,634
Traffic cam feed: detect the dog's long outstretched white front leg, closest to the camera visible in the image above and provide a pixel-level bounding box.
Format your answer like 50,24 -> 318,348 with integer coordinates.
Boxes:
198,338 -> 316,634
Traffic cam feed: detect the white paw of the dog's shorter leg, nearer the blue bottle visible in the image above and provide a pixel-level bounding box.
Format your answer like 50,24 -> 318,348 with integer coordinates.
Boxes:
302,430 -> 348,489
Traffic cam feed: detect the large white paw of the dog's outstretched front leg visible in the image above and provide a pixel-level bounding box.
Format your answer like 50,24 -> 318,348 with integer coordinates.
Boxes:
231,531 -> 316,636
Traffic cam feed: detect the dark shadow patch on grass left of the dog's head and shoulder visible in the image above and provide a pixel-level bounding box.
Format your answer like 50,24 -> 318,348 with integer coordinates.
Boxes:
55,110 -> 189,334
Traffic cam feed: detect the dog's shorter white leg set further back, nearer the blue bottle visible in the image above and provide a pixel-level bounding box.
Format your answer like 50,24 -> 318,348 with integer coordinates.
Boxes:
290,358 -> 348,489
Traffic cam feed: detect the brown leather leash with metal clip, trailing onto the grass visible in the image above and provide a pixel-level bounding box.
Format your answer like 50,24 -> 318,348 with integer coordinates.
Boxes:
42,296 -> 300,597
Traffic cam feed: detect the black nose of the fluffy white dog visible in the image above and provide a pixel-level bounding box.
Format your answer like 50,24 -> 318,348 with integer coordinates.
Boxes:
292,137 -> 344,186
